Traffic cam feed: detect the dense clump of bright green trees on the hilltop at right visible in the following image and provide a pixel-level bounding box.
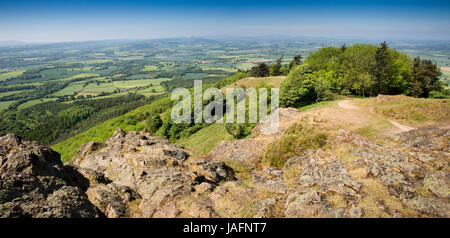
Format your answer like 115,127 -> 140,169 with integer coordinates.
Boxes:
280,42 -> 449,106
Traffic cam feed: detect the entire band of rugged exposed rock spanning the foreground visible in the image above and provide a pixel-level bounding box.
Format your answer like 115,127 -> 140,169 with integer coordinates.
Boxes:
0,125 -> 450,218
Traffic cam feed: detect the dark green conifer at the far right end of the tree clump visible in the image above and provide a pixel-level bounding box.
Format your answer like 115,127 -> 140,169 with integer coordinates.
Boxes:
409,57 -> 442,97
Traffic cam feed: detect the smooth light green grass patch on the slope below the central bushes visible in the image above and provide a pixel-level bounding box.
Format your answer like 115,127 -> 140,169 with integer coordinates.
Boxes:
177,123 -> 233,154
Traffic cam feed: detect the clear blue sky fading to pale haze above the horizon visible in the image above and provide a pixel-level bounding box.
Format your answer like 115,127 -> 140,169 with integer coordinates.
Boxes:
0,0 -> 450,42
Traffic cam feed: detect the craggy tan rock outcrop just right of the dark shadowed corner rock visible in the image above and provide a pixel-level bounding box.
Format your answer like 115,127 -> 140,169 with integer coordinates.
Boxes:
73,129 -> 233,217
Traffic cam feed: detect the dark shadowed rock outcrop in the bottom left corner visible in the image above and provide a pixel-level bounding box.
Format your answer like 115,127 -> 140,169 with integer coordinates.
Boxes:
0,134 -> 102,217
